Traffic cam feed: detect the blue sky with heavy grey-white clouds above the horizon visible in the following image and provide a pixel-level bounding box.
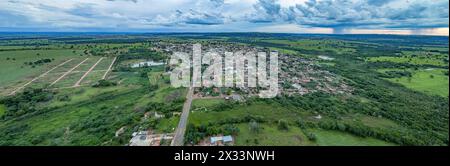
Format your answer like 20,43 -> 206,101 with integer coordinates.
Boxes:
0,0 -> 449,36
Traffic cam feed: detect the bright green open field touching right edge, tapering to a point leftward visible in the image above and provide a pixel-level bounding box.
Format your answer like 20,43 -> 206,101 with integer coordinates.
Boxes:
389,69 -> 449,97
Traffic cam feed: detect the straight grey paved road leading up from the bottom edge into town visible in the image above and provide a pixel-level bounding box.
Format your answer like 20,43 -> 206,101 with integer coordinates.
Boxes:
170,87 -> 194,146
